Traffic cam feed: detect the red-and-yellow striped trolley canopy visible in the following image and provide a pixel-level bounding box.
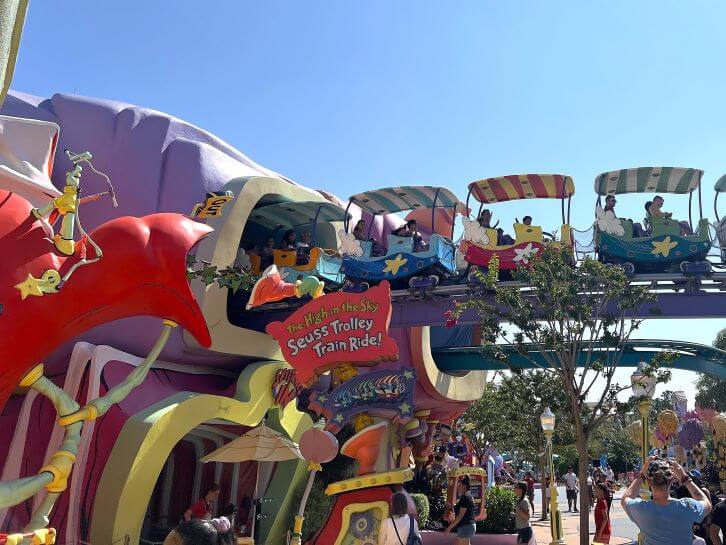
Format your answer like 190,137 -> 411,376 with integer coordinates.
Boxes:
469,174 -> 575,203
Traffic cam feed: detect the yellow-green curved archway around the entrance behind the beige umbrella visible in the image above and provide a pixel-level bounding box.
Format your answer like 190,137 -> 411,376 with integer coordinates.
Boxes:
91,362 -> 312,544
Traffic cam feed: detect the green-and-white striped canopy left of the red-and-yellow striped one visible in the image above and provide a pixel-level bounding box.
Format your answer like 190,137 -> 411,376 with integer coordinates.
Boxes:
350,185 -> 460,214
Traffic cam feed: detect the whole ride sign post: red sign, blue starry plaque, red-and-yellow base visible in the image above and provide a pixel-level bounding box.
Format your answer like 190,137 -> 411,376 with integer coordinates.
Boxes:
262,280 -> 427,545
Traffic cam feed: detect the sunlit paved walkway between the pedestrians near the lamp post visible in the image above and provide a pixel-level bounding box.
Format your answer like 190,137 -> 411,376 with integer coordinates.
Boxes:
532,487 -> 638,545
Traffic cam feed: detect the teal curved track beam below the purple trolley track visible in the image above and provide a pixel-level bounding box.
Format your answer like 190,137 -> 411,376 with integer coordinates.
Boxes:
432,340 -> 726,380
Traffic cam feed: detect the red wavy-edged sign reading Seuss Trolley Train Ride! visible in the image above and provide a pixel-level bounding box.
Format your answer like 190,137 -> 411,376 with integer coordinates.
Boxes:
266,281 -> 398,386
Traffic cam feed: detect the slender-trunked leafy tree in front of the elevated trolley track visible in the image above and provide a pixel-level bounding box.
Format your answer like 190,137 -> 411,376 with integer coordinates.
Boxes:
451,245 -> 672,545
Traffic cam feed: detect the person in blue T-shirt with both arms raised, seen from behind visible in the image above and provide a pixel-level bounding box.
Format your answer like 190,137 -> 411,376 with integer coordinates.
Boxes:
621,457 -> 711,545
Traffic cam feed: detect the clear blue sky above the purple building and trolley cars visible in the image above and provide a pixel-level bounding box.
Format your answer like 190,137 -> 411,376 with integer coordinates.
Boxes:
13,0 -> 726,400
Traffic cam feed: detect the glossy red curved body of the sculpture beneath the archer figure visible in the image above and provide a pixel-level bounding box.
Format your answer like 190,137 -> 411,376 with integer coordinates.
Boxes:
0,190 -> 211,410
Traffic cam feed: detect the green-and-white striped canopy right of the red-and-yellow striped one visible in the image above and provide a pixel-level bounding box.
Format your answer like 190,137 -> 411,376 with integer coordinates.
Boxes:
595,167 -> 703,199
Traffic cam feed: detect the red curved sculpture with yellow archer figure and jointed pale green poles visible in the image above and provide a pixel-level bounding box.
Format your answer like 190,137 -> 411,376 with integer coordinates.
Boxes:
0,182 -> 211,543
